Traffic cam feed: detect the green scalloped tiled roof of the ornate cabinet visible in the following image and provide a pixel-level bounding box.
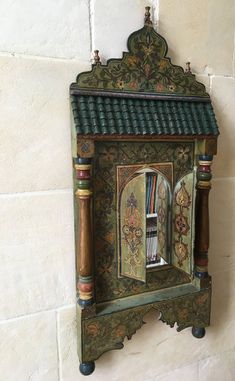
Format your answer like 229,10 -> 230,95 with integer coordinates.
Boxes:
72,95 -> 219,135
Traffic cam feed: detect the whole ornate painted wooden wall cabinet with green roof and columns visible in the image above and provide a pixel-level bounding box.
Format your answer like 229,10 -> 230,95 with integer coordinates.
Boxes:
70,7 -> 218,375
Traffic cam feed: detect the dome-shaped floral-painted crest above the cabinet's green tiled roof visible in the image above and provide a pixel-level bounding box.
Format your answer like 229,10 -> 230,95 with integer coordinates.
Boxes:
77,25 -> 209,97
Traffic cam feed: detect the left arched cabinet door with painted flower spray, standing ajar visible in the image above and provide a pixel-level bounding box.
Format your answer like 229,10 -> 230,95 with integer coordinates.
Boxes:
119,173 -> 146,282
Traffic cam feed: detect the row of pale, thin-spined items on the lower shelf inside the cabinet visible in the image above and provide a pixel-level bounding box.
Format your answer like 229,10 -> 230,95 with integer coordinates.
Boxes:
146,218 -> 160,265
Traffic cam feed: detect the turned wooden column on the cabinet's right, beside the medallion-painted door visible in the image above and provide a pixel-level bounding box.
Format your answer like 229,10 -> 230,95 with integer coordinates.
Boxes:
194,155 -> 213,278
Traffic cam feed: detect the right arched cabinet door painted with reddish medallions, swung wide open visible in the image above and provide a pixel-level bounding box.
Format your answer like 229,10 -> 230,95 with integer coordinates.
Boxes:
172,172 -> 195,274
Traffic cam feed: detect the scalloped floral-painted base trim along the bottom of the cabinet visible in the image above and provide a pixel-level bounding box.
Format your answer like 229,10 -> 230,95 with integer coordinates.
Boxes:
80,288 -> 211,362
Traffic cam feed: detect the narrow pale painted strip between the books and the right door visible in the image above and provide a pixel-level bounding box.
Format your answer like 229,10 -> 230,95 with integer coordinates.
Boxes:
156,174 -> 169,261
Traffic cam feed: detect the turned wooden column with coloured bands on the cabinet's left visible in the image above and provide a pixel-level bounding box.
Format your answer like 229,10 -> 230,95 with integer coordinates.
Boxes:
75,158 -> 94,308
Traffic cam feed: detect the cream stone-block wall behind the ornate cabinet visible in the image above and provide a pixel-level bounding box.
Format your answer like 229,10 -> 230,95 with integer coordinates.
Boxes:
0,0 -> 235,381
